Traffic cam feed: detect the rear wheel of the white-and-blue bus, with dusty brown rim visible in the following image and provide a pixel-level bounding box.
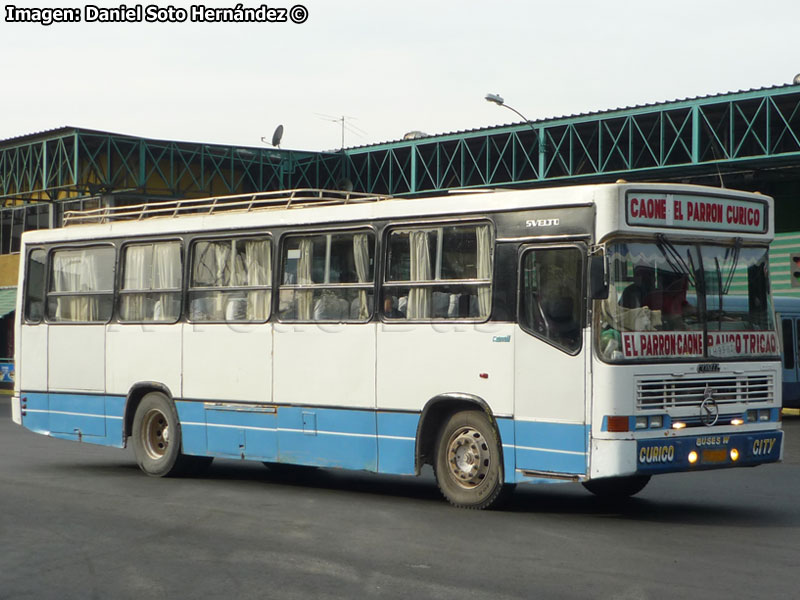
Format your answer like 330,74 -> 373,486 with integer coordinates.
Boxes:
132,392 -> 198,477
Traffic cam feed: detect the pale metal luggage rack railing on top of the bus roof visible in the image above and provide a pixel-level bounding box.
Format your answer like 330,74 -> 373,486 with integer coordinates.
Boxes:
64,188 -> 392,227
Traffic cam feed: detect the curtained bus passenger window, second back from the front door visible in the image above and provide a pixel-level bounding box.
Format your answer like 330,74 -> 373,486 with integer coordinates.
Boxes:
278,232 -> 375,323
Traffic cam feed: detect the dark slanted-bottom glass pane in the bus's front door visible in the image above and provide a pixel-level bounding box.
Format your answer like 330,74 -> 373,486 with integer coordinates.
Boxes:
519,247 -> 584,352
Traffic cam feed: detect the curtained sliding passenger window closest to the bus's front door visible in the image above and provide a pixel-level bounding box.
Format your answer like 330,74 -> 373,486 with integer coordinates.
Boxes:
381,224 -> 493,320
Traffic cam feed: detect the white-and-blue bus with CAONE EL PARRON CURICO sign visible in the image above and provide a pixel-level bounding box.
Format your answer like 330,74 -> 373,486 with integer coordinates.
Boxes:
12,182 -> 783,509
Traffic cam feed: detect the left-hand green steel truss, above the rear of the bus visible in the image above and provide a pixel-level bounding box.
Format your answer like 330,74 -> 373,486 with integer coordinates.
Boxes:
0,129 -> 343,204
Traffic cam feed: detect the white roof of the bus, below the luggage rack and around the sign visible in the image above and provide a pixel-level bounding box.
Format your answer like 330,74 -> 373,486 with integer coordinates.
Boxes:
23,183 -> 772,244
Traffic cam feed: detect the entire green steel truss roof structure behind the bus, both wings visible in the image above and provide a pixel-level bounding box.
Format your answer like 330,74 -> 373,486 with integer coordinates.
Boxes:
0,85 -> 800,204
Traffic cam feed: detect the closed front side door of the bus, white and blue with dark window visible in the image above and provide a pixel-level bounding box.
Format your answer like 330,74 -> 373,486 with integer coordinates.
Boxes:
514,243 -> 589,476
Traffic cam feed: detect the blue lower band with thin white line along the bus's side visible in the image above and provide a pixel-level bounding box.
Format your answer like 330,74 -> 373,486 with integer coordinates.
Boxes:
23,393 -> 589,483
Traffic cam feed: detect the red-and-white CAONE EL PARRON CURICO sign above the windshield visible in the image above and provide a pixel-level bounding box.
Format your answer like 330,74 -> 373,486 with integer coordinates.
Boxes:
625,191 -> 767,233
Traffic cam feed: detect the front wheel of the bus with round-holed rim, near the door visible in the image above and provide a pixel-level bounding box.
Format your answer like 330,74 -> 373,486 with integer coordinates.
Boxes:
434,410 -> 513,510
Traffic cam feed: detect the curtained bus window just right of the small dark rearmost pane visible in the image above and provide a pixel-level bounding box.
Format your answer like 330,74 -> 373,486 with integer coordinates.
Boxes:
47,246 -> 115,323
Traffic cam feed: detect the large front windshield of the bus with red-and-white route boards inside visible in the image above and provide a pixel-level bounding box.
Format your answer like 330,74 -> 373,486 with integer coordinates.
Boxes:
595,236 -> 778,361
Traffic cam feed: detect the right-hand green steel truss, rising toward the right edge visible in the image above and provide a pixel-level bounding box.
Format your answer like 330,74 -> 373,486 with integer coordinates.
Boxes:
346,86 -> 800,195
